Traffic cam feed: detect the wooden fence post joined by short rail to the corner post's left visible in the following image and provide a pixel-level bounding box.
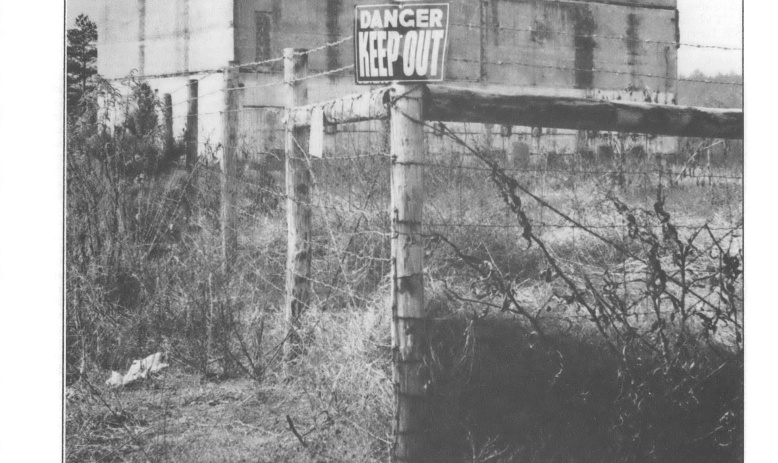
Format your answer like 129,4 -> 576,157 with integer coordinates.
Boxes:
284,48 -> 312,362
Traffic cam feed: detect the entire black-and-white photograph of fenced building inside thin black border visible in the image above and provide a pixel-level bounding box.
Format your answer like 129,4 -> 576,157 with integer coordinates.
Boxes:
0,0 -> 773,463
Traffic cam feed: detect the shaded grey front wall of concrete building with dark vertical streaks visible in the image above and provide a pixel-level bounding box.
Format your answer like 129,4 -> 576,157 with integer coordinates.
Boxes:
230,0 -> 677,102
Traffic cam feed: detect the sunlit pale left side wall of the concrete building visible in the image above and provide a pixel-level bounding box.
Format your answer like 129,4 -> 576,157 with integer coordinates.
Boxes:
96,0 -> 235,156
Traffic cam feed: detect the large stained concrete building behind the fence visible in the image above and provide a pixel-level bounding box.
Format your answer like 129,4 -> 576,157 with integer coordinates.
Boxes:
97,0 -> 679,160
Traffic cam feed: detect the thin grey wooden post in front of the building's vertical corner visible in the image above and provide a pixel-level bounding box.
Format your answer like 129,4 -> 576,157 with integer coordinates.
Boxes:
221,62 -> 240,274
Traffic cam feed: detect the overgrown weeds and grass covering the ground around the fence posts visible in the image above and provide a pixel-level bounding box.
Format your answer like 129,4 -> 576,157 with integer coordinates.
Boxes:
66,75 -> 743,463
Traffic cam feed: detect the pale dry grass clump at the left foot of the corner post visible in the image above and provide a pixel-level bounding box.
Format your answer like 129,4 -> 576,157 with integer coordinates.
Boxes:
278,293 -> 394,461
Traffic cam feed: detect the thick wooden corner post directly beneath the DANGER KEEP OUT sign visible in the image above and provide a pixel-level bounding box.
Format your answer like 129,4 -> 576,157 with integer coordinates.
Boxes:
390,85 -> 430,462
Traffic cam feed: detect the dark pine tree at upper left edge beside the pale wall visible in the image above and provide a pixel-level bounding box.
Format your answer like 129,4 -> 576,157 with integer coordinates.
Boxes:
67,14 -> 97,115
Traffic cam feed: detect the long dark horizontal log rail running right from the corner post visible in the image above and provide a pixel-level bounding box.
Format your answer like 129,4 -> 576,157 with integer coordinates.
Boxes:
424,85 -> 743,139
